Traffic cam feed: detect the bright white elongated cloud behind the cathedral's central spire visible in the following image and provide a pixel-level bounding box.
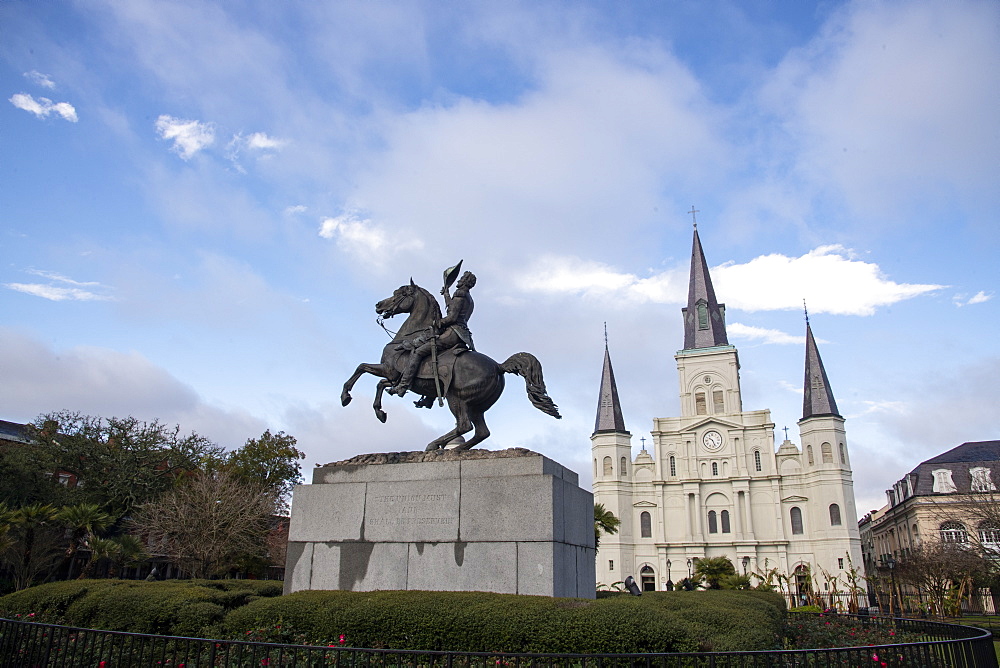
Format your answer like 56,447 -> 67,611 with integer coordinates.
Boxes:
515,245 -> 944,316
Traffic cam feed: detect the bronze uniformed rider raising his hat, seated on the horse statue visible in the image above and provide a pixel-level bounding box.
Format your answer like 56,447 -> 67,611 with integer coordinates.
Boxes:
389,265 -> 476,397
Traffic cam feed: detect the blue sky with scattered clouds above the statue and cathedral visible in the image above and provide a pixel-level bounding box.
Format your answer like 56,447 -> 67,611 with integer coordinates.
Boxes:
0,0 -> 1000,513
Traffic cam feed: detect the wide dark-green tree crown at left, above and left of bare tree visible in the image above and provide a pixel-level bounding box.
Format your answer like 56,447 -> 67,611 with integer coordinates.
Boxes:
29,411 -> 222,518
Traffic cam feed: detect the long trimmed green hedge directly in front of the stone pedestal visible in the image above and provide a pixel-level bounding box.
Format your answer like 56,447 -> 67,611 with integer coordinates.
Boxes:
221,591 -> 785,654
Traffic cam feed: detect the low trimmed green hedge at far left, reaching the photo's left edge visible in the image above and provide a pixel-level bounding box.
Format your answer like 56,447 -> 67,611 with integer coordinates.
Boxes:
0,580 -> 282,637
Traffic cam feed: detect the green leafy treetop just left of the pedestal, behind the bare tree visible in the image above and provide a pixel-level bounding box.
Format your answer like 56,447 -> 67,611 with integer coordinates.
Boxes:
223,429 -> 306,509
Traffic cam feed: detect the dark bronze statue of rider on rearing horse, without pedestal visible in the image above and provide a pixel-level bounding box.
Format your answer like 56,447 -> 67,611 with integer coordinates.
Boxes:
340,261 -> 562,450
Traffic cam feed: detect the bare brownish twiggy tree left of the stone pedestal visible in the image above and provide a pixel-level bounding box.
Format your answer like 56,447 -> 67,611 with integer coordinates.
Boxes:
132,470 -> 276,577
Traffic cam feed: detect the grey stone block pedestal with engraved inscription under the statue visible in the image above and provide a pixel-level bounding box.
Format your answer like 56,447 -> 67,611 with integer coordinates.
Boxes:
285,449 -> 595,598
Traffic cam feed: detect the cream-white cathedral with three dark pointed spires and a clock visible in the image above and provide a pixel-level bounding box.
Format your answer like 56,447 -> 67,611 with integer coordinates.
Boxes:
591,228 -> 862,591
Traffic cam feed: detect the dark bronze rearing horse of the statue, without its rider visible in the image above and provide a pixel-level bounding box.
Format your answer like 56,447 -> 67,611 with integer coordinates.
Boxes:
340,279 -> 562,450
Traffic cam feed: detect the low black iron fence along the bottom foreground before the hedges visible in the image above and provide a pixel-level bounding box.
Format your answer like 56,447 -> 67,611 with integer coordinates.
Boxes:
0,617 -> 997,668
